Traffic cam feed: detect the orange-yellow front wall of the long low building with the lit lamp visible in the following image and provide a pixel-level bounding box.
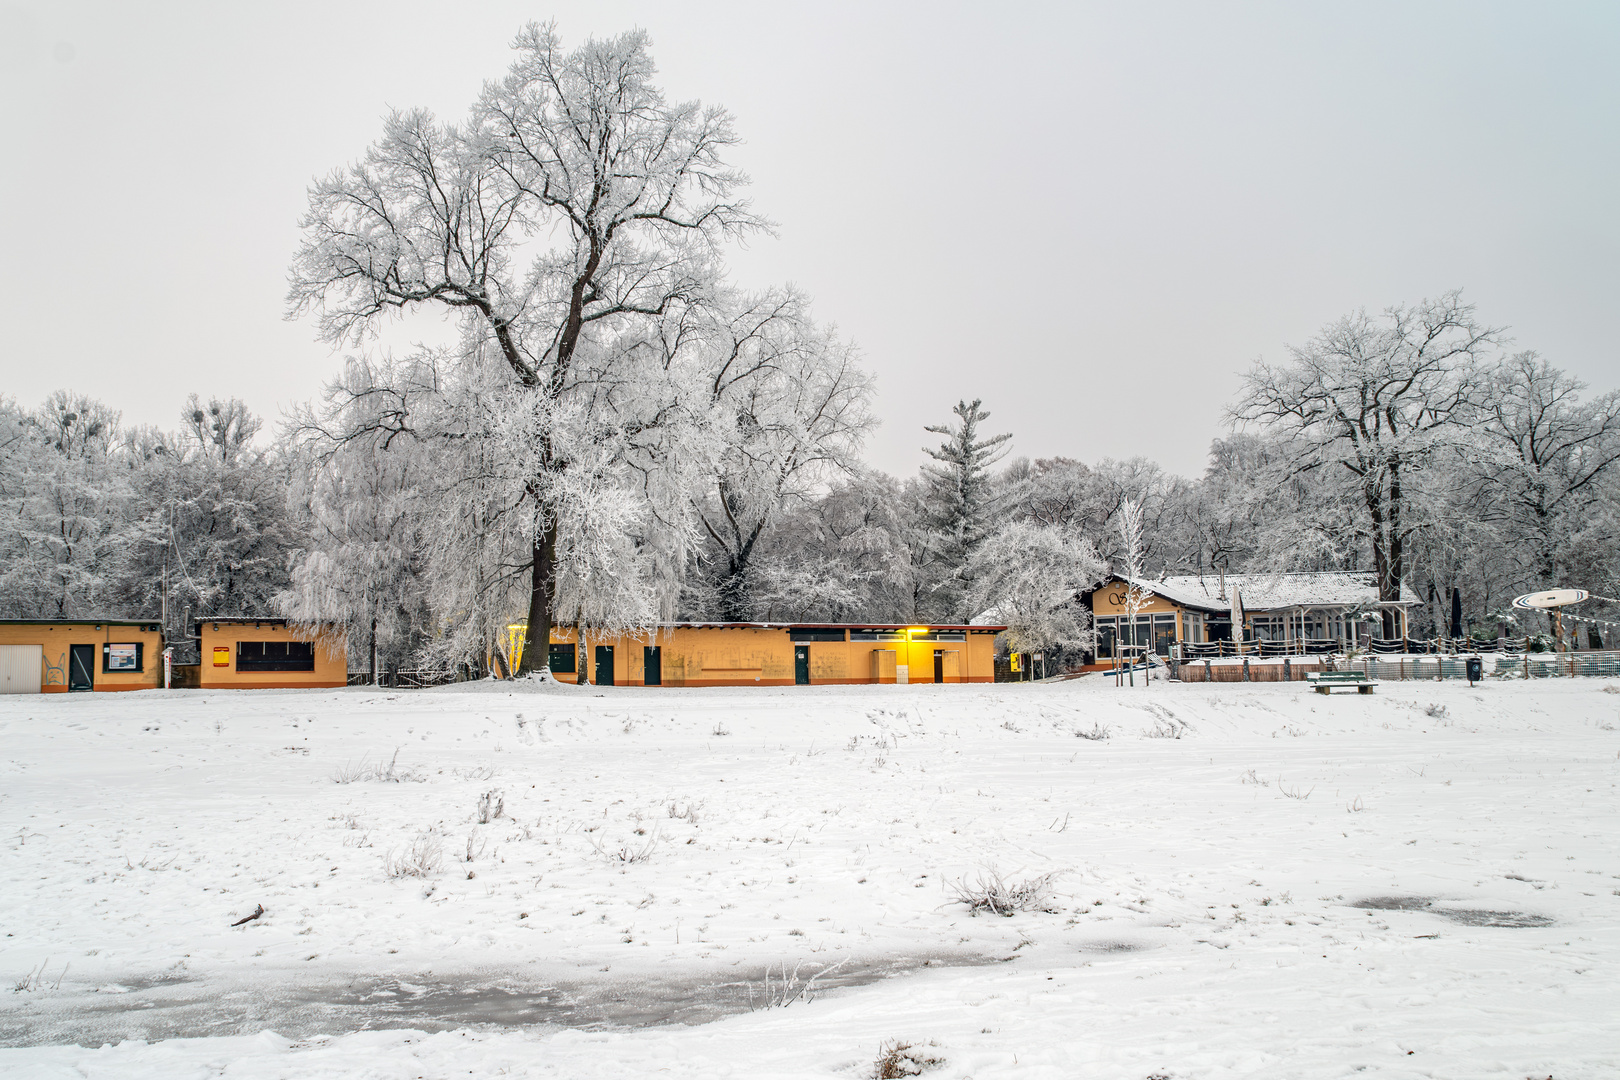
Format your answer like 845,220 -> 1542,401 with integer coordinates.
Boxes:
544,627 -> 996,687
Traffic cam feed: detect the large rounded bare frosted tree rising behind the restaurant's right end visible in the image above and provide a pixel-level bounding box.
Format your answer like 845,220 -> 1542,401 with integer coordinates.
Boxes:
1233,291 -> 1502,635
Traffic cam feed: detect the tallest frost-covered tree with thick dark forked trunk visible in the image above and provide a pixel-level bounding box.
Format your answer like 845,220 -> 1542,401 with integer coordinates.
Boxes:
290,24 -> 761,670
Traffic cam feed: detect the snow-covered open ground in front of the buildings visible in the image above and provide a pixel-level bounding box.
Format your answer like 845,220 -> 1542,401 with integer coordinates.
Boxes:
0,677 -> 1620,1080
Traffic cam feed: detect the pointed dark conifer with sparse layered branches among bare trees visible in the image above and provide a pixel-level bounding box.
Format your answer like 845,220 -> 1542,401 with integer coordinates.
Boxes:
922,398 -> 1016,622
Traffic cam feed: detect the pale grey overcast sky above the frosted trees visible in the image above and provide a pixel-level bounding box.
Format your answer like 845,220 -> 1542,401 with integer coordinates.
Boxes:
0,0 -> 1620,474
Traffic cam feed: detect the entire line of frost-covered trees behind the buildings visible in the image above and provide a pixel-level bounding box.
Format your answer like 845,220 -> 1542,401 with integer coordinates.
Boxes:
0,26 -> 1620,672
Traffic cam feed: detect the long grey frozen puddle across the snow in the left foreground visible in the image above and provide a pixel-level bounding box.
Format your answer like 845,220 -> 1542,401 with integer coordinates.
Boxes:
0,954 -> 1000,1046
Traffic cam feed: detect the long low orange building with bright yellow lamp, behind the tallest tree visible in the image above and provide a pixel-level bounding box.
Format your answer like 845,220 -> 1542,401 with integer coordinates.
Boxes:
531,622 -> 1006,687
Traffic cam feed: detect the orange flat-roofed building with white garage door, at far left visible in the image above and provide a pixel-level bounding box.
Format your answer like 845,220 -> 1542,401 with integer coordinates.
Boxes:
0,619 -> 164,693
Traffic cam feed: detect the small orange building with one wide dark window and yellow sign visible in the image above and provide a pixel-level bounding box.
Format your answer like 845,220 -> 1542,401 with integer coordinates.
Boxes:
194,617 -> 348,690
